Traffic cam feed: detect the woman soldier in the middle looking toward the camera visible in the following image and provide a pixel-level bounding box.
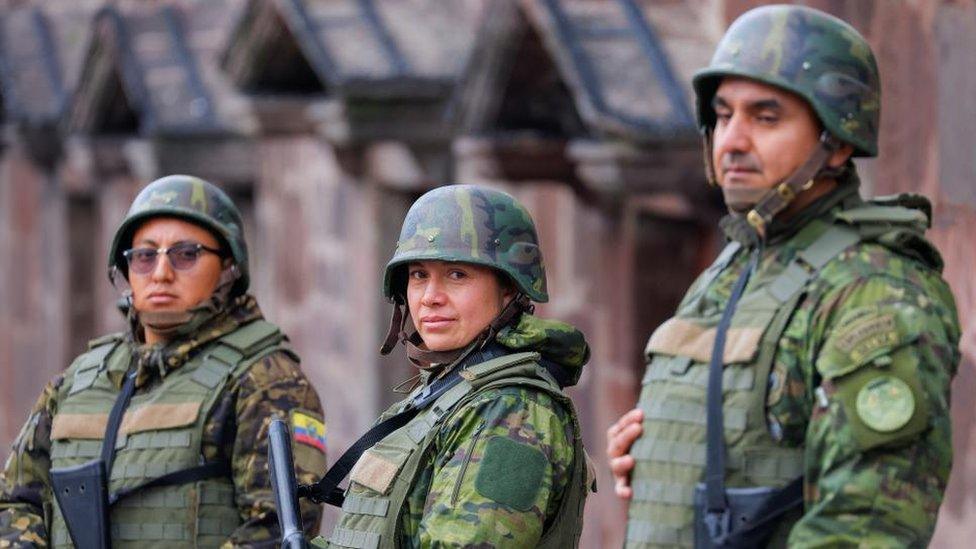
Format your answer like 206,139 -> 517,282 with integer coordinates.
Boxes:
317,185 -> 589,547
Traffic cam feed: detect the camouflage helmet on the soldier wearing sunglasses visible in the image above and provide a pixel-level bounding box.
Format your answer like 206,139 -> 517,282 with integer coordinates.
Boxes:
108,175 -> 250,296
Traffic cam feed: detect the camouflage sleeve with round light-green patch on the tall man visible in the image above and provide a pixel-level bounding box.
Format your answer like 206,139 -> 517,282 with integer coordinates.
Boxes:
771,259 -> 959,547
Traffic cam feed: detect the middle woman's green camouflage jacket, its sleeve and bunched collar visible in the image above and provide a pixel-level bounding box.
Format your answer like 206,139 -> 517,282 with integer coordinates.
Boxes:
390,315 -> 587,547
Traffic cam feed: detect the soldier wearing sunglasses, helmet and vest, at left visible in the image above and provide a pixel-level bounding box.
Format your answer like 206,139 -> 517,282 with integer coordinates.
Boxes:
0,175 -> 325,547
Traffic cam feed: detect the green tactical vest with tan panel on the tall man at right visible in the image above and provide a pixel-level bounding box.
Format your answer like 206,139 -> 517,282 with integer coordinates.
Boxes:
626,204 -> 925,549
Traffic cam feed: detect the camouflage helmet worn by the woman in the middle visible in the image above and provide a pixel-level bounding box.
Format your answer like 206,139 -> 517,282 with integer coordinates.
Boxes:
383,185 -> 549,303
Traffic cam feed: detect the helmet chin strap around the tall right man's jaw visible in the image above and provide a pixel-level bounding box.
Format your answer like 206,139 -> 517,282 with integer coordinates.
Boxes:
702,128 -> 843,239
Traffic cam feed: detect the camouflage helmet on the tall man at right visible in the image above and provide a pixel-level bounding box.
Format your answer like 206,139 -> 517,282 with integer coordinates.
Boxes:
694,5 -> 881,156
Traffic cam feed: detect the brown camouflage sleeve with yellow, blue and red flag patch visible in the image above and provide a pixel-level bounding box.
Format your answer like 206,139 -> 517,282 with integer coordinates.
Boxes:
215,353 -> 326,547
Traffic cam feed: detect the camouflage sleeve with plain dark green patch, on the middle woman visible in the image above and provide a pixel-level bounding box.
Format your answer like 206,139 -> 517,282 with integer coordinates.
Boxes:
410,387 -> 574,547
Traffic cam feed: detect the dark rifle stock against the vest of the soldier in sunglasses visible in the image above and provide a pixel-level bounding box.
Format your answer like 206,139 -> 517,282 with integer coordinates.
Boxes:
50,459 -> 111,549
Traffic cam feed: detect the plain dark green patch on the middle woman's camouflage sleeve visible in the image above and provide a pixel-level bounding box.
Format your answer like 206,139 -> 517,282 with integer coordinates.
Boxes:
474,437 -> 546,512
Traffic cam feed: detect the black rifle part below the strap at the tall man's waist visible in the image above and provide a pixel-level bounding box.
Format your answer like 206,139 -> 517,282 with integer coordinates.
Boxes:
694,477 -> 803,549
